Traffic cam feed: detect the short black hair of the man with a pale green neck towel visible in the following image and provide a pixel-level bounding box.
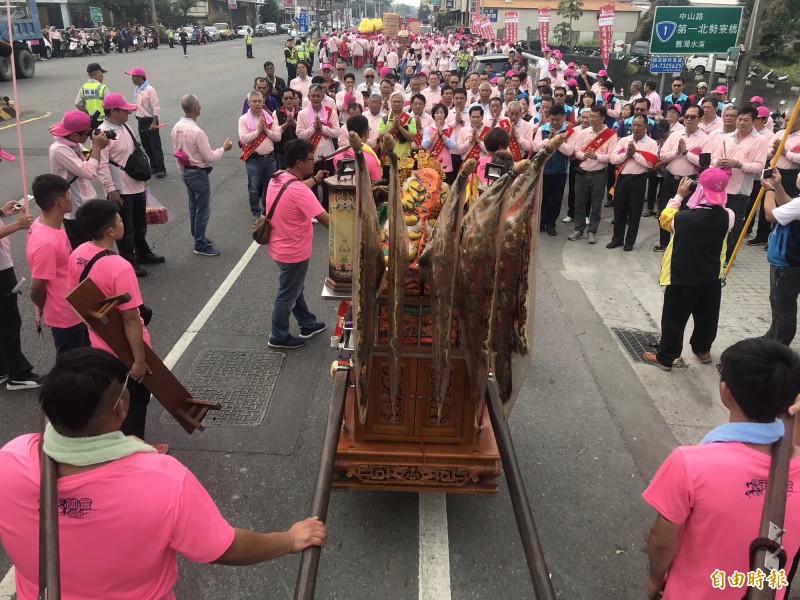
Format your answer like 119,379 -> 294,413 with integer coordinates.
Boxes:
39,350 -> 128,436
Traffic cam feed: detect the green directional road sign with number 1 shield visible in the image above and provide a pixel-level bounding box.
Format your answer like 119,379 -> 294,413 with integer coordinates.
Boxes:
650,6 -> 742,54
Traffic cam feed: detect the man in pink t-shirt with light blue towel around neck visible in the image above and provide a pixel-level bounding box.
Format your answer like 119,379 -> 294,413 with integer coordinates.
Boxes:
642,338 -> 800,600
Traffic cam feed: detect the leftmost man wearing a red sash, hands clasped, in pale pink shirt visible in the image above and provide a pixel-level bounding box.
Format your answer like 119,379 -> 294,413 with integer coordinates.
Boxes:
239,91 -> 282,219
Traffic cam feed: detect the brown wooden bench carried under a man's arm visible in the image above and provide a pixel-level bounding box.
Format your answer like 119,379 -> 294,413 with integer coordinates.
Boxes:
67,277 -> 220,433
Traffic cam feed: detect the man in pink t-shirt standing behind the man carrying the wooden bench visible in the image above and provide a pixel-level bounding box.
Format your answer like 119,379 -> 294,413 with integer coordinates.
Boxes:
25,173 -> 89,357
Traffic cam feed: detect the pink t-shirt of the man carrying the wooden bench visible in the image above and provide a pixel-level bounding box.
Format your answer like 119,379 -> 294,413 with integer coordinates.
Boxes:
67,242 -> 150,356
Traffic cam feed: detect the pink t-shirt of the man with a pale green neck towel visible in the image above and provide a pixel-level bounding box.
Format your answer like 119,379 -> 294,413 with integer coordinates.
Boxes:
0,433 -> 234,600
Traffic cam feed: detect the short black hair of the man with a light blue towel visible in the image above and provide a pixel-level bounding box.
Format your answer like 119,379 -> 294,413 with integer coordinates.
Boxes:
720,338 -> 800,423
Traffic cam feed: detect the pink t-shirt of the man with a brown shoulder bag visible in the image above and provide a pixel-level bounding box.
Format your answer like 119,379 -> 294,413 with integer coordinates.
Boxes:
264,172 -> 324,263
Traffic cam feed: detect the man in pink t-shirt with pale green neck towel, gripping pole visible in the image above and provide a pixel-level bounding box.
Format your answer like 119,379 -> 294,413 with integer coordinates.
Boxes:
0,346 -> 327,600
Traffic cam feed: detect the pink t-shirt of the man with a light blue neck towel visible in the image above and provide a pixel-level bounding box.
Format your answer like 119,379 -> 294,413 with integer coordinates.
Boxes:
642,442 -> 800,600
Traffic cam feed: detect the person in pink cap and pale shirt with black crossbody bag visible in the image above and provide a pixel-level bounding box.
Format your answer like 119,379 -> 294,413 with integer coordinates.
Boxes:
99,94 -> 164,277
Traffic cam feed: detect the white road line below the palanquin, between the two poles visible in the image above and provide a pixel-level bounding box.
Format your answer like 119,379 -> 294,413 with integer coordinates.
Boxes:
419,493 -> 451,600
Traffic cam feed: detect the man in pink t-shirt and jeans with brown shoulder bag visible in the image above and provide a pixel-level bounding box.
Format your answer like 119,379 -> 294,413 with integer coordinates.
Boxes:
264,139 -> 328,349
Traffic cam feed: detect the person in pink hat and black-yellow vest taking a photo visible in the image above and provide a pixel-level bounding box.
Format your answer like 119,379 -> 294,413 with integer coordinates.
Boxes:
642,168 -> 735,371
